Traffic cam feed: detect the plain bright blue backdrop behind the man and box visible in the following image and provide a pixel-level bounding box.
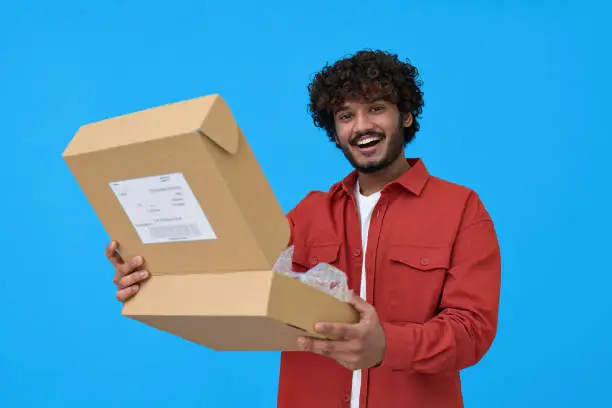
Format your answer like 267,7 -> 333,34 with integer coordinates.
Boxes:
0,0 -> 612,408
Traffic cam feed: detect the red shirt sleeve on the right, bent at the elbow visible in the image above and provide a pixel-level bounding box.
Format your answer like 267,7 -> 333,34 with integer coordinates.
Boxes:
379,193 -> 501,373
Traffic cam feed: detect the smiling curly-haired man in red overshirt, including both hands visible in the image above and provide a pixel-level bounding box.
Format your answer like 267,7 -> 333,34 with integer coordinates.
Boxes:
108,51 -> 501,408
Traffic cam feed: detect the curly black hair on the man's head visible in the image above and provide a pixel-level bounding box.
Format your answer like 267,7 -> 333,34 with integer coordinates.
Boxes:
308,50 -> 424,144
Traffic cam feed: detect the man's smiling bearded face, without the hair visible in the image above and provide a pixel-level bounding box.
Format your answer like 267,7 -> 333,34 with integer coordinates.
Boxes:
334,100 -> 412,173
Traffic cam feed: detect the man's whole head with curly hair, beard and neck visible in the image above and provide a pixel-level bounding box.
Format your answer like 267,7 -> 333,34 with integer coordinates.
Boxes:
308,50 -> 424,178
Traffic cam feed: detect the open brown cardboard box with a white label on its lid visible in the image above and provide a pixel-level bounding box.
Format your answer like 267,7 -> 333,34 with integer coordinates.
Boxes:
63,95 -> 358,351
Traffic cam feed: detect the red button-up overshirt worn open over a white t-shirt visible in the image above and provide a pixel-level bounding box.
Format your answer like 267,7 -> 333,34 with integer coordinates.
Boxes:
278,159 -> 501,408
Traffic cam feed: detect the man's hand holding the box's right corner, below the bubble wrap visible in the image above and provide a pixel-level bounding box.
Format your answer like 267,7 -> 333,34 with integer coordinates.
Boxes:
299,294 -> 386,370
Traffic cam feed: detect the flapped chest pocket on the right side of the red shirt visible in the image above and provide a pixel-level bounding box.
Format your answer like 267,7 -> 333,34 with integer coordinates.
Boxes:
378,244 -> 450,323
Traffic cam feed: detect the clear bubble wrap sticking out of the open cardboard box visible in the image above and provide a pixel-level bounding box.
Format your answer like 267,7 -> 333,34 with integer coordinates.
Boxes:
273,246 -> 350,302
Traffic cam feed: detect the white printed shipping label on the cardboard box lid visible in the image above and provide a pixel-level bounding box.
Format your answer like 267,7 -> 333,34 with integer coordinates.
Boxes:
109,173 -> 217,244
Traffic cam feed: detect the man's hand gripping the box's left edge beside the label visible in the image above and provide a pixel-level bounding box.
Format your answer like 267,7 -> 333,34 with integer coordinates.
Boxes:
106,241 -> 149,303
